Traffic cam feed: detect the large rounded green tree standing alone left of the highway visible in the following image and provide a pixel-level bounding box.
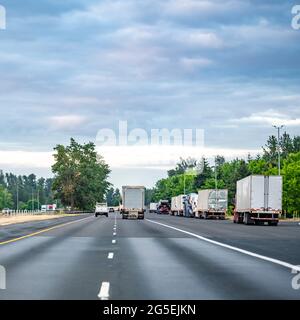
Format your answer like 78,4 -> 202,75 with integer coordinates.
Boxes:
52,138 -> 110,210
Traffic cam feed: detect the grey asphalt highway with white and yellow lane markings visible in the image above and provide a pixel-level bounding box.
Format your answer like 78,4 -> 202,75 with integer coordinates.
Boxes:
0,213 -> 300,300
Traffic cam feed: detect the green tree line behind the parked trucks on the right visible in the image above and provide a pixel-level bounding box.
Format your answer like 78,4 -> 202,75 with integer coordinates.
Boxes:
151,132 -> 300,214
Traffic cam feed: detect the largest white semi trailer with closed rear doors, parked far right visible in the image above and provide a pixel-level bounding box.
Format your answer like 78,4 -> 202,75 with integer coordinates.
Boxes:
233,175 -> 282,226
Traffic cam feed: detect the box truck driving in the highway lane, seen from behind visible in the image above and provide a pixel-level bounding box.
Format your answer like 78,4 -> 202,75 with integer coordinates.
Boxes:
121,186 -> 145,219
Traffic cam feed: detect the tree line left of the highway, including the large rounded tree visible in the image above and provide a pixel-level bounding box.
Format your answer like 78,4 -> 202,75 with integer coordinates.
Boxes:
0,139 -> 112,210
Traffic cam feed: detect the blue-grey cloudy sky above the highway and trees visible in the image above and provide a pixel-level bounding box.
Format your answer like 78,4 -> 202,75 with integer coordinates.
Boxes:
0,0 -> 300,186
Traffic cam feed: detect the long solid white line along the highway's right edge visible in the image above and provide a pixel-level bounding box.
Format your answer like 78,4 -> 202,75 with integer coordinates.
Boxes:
146,219 -> 300,272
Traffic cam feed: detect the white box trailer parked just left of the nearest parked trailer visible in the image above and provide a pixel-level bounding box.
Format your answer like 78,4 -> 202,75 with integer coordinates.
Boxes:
195,189 -> 228,219
